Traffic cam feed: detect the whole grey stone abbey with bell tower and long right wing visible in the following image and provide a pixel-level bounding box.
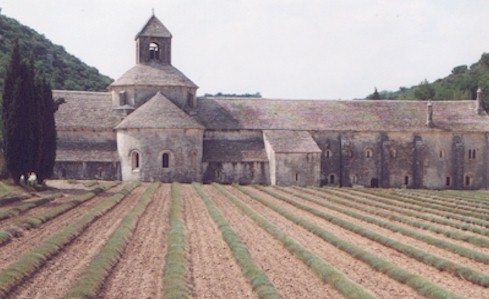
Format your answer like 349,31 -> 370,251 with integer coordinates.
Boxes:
54,15 -> 489,189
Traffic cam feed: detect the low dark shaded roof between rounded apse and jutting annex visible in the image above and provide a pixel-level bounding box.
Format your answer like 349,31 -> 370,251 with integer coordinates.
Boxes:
202,139 -> 268,162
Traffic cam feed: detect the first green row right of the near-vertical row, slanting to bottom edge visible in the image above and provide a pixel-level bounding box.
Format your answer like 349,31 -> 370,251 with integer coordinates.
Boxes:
192,183 -> 283,299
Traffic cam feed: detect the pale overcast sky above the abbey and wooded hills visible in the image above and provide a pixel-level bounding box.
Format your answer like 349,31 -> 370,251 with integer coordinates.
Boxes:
0,0 -> 489,99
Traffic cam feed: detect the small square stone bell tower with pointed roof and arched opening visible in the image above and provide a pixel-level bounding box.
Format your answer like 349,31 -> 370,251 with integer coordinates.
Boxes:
136,14 -> 172,65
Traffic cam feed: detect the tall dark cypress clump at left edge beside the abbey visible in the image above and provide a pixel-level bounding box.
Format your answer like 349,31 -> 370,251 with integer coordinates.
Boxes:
2,42 -> 56,183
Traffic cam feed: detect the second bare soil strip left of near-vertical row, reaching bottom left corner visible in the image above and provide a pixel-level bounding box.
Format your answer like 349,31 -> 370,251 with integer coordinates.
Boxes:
11,184 -> 148,299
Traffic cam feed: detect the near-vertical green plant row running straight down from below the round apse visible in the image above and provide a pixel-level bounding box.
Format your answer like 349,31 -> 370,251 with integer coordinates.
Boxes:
162,183 -> 190,299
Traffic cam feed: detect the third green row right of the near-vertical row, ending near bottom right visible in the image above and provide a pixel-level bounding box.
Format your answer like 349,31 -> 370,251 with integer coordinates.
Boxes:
239,187 -> 462,299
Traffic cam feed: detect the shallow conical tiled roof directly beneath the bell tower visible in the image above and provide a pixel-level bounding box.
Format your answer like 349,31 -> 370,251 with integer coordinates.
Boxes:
109,63 -> 197,89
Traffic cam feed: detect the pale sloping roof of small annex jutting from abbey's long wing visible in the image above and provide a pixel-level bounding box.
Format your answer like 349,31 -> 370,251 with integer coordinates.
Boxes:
263,130 -> 321,153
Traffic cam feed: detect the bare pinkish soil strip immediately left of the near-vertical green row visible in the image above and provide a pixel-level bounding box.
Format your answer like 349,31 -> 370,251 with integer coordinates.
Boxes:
99,184 -> 171,298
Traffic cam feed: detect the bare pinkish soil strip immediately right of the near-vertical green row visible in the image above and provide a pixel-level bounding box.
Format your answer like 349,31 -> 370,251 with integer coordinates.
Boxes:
181,185 -> 256,299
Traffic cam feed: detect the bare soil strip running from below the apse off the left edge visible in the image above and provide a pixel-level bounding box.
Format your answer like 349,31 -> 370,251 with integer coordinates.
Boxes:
0,184 -> 124,271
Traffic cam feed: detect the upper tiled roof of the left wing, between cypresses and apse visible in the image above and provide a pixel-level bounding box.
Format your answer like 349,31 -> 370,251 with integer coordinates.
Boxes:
53,90 -> 119,129
